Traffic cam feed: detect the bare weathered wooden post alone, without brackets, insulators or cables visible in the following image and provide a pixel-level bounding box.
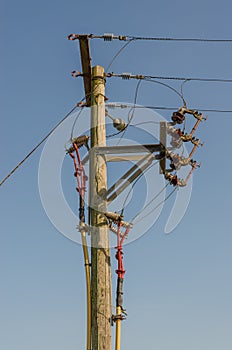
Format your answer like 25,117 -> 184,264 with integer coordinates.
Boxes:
89,66 -> 112,350
